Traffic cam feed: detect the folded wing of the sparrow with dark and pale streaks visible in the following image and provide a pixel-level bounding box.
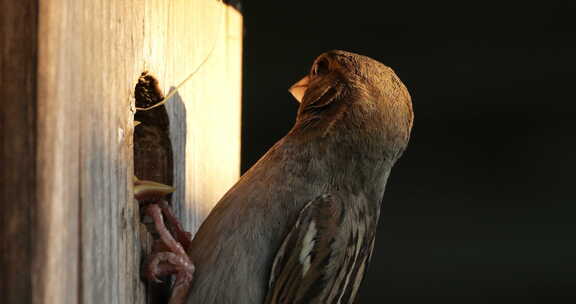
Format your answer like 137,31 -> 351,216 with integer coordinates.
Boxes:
265,195 -> 374,304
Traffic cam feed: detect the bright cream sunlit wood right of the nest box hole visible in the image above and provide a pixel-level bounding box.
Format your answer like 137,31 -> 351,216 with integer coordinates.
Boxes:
161,0 -> 242,232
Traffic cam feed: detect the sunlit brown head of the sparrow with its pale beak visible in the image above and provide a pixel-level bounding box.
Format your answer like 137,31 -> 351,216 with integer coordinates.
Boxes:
290,50 -> 414,157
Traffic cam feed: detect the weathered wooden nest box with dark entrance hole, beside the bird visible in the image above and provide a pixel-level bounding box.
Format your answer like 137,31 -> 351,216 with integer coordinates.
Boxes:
0,0 -> 242,303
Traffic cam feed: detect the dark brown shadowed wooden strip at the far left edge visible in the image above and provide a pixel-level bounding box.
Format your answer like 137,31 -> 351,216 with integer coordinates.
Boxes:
0,0 -> 38,303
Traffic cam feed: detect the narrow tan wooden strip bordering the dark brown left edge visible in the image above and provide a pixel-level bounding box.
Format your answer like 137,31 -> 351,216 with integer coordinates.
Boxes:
33,2 -> 82,303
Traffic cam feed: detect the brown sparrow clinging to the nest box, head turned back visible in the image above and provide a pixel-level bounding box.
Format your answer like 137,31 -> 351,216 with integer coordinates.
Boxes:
135,50 -> 414,304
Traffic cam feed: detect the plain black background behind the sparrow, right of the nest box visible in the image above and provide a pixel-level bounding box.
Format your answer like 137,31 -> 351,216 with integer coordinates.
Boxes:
242,1 -> 576,303
